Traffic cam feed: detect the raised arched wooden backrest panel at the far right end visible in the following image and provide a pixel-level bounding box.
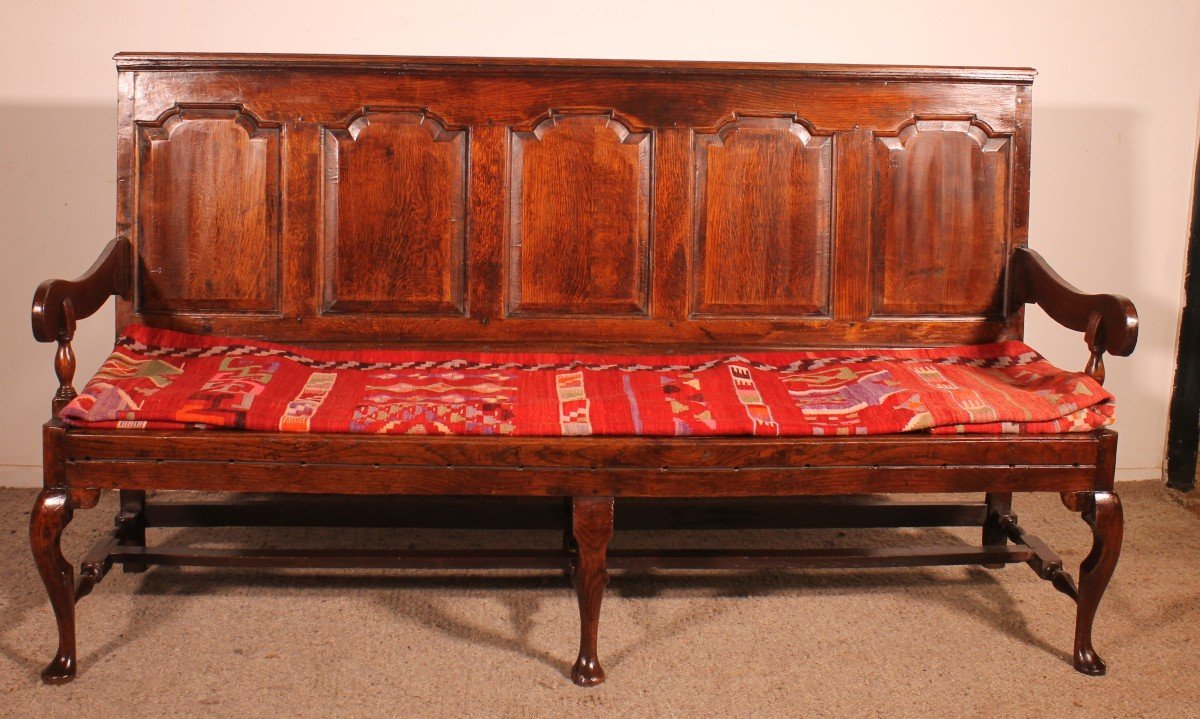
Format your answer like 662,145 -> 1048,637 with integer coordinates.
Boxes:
872,119 -> 1012,317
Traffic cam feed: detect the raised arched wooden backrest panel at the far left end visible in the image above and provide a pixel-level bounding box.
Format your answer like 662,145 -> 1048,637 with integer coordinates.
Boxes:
137,104 -> 280,312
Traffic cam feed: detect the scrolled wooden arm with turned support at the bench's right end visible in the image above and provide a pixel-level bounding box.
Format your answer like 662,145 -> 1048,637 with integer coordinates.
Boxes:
1009,247 -> 1138,383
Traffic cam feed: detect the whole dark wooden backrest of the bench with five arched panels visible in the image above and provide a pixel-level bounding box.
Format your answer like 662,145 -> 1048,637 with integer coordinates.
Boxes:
118,54 -> 1033,349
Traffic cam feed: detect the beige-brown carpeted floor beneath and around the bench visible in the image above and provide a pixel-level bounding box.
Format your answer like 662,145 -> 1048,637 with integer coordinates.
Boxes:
0,481 -> 1200,719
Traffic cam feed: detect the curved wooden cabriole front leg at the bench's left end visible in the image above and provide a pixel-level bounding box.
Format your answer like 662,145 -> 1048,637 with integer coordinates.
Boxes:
29,487 -> 76,684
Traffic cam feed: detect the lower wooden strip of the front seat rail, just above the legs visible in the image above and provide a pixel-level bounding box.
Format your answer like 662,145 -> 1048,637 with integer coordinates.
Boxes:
58,461 -> 1096,497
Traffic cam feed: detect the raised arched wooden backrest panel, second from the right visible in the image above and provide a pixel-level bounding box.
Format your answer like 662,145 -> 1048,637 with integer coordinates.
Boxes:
691,115 -> 833,317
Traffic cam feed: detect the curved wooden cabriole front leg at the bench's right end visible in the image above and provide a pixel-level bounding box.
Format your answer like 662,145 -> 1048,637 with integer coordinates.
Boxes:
1062,492 -> 1124,676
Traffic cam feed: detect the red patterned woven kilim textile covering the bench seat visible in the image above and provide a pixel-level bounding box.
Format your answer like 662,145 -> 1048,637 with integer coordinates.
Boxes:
62,325 -> 1114,437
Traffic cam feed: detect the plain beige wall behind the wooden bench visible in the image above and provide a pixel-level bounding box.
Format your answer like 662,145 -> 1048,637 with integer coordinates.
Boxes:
0,0 -> 1200,485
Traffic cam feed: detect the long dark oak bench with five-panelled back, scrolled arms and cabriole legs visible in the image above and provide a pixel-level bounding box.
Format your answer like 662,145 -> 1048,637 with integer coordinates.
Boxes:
30,54 -> 1136,685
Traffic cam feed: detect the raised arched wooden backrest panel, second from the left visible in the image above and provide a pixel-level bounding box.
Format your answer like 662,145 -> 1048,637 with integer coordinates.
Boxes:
322,108 -> 467,314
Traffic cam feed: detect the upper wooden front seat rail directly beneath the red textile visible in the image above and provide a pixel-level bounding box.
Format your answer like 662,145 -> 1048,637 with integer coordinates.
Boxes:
64,427 -> 1099,469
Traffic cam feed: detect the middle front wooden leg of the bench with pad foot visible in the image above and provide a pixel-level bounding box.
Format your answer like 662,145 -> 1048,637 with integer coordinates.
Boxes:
571,497 -> 613,687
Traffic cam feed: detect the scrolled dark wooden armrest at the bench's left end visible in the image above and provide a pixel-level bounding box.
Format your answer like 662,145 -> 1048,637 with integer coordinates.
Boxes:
32,238 -> 132,342
